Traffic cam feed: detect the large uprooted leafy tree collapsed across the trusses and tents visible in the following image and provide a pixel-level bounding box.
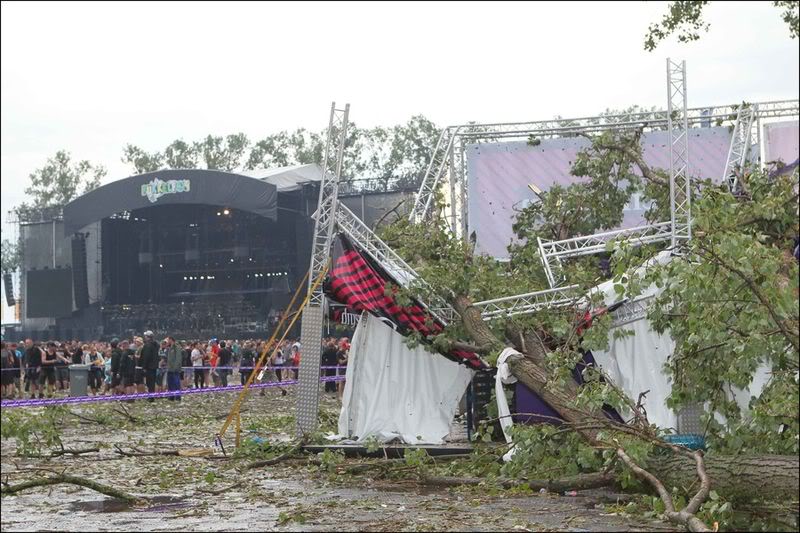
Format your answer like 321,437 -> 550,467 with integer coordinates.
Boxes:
376,125 -> 800,531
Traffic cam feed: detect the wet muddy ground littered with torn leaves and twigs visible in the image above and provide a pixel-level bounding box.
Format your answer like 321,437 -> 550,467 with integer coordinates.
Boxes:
1,390 -> 671,531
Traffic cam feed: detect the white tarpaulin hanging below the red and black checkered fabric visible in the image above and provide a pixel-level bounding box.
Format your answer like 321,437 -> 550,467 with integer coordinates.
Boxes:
339,314 -> 473,444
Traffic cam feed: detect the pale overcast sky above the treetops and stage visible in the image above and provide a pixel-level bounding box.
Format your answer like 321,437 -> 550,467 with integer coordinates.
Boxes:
0,2 -> 800,320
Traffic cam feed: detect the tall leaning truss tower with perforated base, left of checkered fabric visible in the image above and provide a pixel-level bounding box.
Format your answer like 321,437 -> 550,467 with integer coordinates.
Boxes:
297,102 -> 350,435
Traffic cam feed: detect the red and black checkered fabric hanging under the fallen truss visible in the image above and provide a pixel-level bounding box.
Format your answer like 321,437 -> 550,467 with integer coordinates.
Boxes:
324,235 -> 487,369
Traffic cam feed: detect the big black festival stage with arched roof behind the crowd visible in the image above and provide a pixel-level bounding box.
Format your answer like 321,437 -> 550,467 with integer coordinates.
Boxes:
17,165 -> 321,339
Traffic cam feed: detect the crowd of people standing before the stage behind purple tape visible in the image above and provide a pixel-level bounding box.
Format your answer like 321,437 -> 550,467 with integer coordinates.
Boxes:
0,331 -> 350,401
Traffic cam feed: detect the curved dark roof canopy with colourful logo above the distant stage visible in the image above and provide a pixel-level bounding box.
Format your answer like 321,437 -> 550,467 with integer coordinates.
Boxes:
64,165 -> 278,235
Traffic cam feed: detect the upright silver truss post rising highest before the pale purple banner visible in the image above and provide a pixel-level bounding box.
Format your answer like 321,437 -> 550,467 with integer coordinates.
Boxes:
667,58 -> 692,247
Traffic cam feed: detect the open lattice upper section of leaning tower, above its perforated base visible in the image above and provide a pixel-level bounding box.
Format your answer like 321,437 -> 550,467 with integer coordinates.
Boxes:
308,102 -> 350,306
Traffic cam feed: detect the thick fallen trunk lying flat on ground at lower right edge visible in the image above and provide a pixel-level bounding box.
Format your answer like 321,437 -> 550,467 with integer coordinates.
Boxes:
648,455 -> 800,500
